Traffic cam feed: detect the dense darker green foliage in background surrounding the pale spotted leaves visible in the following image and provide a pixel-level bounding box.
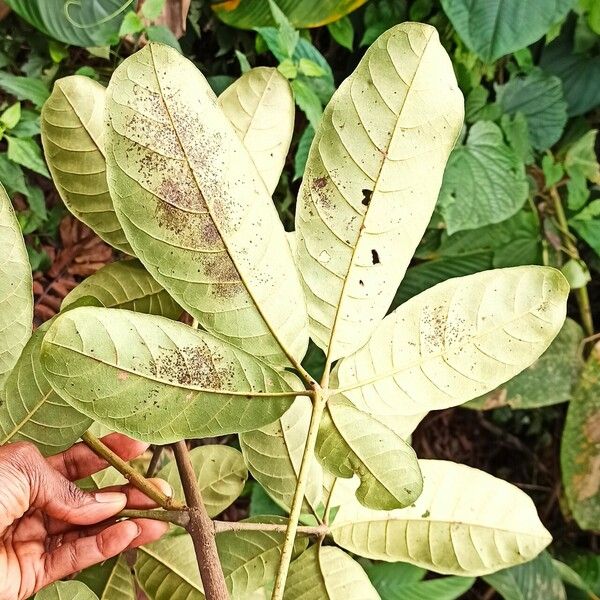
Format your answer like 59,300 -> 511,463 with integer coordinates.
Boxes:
0,0 -> 600,600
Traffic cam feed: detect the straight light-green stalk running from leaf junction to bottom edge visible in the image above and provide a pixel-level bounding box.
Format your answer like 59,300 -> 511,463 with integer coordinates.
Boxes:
271,388 -> 327,600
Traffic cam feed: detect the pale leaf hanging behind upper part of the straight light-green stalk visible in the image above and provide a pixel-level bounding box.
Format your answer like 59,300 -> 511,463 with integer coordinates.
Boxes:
240,397 -> 323,513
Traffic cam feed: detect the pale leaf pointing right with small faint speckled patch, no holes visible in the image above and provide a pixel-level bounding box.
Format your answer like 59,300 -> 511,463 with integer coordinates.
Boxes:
334,266 -> 569,423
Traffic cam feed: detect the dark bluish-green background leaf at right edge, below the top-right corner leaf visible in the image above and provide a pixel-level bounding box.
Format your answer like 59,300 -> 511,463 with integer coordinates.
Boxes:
540,28 -> 600,116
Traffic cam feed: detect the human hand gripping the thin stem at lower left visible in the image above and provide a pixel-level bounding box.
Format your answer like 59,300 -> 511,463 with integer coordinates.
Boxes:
0,434 -> 172,600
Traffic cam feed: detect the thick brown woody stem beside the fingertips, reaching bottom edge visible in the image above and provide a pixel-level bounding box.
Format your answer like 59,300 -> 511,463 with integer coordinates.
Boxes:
173,441 -> 229,600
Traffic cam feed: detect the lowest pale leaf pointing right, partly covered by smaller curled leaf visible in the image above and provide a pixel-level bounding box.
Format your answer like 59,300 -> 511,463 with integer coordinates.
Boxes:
331,460 -> 552,576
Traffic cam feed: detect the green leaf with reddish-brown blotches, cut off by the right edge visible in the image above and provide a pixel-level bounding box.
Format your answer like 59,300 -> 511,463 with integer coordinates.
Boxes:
560,344 -> 600,530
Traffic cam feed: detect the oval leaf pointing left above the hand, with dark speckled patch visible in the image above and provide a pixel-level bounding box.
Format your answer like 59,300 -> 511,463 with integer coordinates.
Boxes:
42,307 -> 294,444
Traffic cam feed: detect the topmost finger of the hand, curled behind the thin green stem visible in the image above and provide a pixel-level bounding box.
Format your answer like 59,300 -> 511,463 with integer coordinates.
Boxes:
47,433 -> 148,481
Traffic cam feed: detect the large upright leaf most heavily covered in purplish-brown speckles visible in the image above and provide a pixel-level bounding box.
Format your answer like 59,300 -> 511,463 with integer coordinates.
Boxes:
107,44 -> 308,364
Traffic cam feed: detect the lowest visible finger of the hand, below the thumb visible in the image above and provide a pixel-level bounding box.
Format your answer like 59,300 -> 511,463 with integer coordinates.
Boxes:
40,521 -> 142,587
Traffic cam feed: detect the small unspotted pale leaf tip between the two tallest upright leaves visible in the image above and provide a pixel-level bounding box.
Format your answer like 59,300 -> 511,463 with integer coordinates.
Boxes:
219,67 -> 295,194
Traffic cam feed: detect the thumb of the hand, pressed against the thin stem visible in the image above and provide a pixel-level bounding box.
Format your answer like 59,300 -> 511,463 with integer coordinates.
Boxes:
2,443 -> 127,525
